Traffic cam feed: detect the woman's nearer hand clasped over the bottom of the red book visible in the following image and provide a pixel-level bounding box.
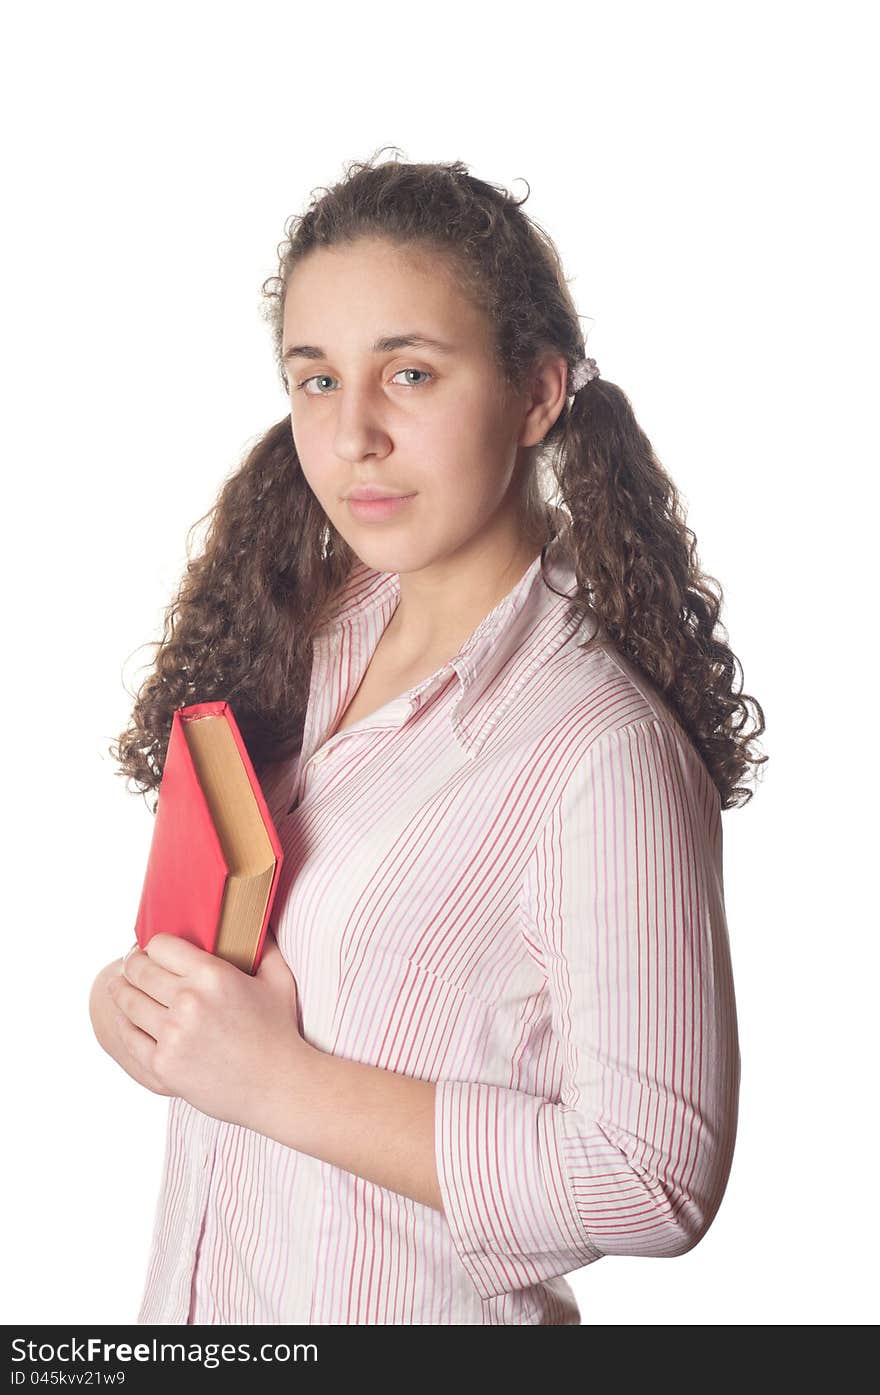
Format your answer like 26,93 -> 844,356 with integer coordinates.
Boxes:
107,930 -> 312,1126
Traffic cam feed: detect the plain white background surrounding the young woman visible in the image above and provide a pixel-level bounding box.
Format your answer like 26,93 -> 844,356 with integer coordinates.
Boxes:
0,0 -> 879,1325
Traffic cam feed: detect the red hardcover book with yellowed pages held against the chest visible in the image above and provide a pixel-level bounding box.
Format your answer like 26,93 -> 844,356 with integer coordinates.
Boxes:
135,702 -> 282,974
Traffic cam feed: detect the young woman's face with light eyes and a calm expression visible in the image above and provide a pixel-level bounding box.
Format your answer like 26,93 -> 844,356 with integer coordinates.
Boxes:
283,240 -> 549,571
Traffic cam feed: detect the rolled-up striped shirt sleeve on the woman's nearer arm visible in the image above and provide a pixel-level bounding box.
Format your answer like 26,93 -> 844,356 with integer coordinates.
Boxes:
435,718 -> 741,1299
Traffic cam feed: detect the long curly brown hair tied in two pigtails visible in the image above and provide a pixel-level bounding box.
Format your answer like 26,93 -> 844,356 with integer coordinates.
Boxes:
110,146 -> 767,809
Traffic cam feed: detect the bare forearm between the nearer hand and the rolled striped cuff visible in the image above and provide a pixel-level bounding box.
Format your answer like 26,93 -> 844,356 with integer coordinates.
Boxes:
255,1043 -> 443,1212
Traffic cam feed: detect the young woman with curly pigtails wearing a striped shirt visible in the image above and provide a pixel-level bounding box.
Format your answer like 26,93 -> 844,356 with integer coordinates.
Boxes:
92,159 -> 767,1325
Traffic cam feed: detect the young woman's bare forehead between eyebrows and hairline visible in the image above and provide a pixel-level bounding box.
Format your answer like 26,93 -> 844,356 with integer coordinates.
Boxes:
285,239 -> 488,350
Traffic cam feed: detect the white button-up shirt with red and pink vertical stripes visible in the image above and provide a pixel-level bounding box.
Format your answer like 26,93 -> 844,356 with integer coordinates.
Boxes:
137,537 -> 739,1325
